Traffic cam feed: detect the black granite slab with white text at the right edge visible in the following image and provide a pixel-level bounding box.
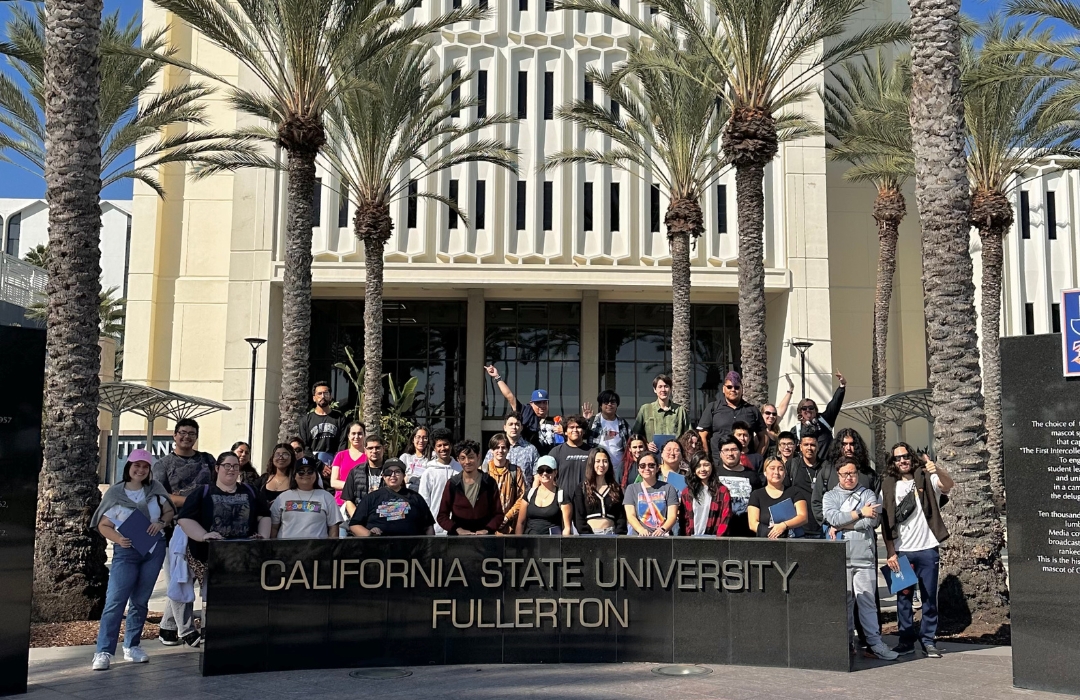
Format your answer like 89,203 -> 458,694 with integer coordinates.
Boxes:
1001,334 -> 1080,694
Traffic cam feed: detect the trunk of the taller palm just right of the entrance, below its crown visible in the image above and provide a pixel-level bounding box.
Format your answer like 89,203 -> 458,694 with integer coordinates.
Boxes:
735,163 -> 769,406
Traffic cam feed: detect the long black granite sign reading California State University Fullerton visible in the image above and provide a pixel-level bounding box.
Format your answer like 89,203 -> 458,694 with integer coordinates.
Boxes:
203,537 -> 849,675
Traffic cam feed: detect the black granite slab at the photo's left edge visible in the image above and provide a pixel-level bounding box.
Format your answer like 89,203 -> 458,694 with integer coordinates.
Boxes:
0,326 -> 45,696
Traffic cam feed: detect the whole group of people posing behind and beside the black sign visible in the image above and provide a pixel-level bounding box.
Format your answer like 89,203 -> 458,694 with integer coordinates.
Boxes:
92,367 -> 953,670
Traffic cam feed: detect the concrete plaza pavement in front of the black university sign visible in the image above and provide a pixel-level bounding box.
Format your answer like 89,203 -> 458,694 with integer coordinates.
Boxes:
27,635 -> 1070,700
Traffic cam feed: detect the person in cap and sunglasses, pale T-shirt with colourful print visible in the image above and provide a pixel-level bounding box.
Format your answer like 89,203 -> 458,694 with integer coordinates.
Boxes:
270,457 -> 341,539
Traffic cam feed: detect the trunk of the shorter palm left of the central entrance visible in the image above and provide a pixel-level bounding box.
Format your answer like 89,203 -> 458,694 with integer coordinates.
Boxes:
353,202 -> 394,434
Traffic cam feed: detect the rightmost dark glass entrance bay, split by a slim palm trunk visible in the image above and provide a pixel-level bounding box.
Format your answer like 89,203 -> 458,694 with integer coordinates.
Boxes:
599,304 -> 740,419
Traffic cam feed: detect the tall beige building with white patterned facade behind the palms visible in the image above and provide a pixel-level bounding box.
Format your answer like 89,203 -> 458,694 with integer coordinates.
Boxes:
124,0 -> 926,460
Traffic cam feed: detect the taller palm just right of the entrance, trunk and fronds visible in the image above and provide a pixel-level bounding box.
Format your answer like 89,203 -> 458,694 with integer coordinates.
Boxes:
561,0 -> 907,404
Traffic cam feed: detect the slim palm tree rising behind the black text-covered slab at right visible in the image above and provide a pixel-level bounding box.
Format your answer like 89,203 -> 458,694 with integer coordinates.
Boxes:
963,15 -> 1080,506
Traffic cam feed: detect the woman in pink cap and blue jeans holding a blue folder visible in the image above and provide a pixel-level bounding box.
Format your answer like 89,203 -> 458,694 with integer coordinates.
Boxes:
91,449 -> 174,671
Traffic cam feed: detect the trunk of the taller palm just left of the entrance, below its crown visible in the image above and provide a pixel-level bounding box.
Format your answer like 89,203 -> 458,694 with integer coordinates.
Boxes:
278,149 -> 318,442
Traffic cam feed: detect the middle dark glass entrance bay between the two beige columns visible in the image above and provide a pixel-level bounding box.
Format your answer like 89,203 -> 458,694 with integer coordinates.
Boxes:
484,301 -> 581,418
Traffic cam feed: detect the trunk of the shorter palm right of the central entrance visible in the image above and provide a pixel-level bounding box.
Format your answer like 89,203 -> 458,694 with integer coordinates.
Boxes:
664,196 -> 704,407
